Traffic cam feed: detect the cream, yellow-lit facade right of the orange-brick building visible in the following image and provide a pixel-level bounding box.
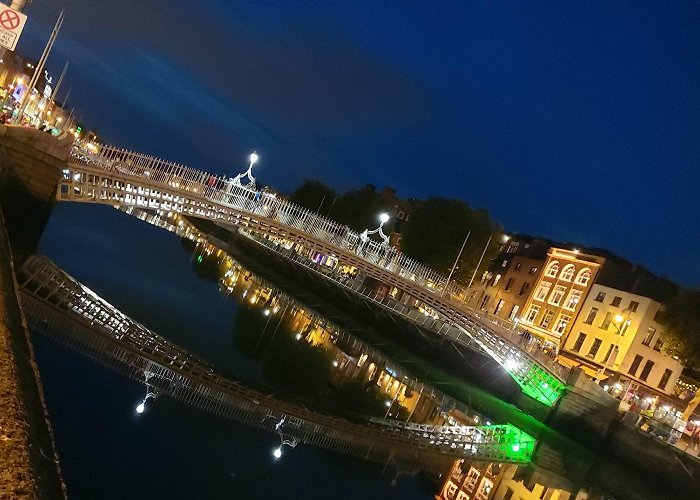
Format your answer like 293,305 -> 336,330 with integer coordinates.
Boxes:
562,284 -> 683,395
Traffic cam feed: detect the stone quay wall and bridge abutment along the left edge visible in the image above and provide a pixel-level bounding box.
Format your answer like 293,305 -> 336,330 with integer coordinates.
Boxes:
0,125 -> 70,499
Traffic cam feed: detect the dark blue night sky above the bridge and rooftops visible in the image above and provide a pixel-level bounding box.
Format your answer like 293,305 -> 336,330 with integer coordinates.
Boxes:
19,0 -> 700,286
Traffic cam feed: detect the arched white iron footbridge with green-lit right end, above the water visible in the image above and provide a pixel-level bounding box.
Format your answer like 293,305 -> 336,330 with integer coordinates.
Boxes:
57,146 -> 567,406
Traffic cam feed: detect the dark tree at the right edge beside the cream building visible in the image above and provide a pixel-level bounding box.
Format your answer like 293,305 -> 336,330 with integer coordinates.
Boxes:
659,289 -> 700,368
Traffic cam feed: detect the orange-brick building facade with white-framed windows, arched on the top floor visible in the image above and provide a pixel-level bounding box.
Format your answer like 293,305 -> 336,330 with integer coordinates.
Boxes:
520,247 -> 605,347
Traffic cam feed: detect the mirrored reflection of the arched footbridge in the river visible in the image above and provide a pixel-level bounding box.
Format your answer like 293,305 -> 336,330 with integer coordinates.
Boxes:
18,256 -> 536,473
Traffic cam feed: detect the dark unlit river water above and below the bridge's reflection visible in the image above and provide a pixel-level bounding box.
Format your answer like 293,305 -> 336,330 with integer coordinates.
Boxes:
34,204 -> 437,499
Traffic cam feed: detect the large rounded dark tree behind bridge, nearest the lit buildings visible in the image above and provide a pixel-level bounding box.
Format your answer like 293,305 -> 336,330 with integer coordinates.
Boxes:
401,197 -> 502,282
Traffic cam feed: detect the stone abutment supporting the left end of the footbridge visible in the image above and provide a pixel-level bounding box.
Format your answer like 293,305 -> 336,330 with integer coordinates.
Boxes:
0,125 -> 73,265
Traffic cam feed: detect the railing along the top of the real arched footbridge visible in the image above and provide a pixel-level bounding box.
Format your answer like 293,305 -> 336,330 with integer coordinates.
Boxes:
65,145 -> 566,394
